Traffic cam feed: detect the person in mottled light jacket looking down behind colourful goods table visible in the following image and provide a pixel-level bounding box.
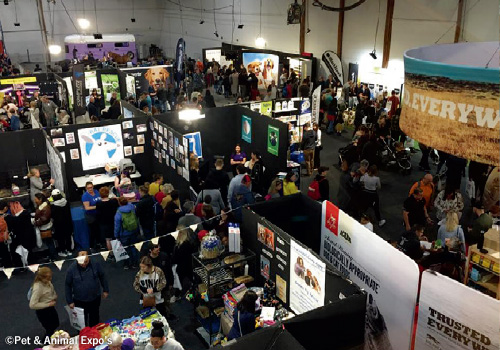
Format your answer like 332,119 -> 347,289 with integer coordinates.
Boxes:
134,256 -> 167,316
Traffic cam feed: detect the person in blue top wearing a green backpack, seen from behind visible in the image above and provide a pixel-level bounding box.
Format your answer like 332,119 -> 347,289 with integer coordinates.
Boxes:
115,197 -> 139,270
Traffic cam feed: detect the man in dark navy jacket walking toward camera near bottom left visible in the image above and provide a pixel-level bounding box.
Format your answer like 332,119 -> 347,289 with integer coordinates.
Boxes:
65,251 -> 109,327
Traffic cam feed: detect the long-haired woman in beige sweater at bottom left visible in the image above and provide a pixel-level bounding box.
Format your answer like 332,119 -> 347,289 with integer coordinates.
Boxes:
30,266 -> 59,338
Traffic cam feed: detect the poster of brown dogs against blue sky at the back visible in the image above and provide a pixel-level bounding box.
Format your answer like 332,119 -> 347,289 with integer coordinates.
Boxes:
243,52 -> 279,90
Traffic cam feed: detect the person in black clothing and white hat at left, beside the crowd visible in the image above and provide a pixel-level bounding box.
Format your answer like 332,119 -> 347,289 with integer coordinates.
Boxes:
49,189 -> 73,258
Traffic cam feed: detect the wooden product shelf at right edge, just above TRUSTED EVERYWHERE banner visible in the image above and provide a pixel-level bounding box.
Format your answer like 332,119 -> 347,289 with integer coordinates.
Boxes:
464,245 -> 500,300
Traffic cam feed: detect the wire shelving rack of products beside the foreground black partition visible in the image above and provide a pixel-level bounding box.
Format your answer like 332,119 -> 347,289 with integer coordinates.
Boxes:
193,249 -> 255,347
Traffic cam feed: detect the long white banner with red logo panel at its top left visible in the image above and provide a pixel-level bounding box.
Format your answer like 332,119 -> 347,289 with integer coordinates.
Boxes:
320,201 -> 419,350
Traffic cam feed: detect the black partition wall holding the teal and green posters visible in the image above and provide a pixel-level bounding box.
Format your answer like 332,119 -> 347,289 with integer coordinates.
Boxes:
155,105 -> 288,180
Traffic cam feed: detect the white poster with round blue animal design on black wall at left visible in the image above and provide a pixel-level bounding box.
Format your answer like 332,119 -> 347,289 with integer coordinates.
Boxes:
78,124 -> 124,171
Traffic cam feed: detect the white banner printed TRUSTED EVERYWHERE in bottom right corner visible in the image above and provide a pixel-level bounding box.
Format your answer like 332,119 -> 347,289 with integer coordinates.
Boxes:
415,270 -> 500,350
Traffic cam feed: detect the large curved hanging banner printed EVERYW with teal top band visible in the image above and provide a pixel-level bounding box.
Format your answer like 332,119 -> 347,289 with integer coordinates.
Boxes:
400,42 -> 500,165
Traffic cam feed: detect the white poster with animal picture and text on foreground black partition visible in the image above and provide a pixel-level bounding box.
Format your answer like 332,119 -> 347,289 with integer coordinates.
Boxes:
290,239 -> 326,314
